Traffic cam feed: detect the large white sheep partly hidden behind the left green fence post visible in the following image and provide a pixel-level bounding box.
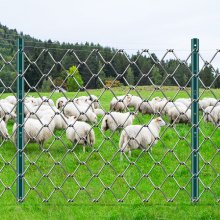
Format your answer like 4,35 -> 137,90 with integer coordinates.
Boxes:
13,115 -> 55,148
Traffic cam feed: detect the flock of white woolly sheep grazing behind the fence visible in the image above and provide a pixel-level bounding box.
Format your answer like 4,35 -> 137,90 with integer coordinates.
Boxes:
0,94 -> 220,155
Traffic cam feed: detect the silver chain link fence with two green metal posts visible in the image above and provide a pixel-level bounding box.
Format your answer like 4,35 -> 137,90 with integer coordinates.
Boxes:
0,38 -> 220,203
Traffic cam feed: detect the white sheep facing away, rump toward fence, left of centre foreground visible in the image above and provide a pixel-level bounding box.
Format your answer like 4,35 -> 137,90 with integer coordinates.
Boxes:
66,117 -> 95,153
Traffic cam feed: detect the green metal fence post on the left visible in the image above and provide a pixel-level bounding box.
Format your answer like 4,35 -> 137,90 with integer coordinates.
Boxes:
16,38 -> 24,202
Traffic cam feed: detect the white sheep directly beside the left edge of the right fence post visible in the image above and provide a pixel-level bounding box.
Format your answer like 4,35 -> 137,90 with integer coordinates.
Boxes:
167,105 -> 191,124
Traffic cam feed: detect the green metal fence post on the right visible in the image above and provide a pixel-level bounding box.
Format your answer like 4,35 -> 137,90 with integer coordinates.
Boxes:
191,38 -> 199,202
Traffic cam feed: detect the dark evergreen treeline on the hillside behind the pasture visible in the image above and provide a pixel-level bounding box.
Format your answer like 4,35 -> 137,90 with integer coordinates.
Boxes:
0,24 -> 220,92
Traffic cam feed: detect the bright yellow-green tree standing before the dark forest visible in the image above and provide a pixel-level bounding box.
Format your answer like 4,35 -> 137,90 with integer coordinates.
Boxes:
67,66 -> 83,92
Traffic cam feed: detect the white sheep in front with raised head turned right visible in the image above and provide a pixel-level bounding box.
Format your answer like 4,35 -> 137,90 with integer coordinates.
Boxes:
119,117 -> 166,159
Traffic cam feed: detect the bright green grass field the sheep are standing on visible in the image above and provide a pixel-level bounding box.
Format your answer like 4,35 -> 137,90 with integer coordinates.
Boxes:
0,87 -> 220,219
